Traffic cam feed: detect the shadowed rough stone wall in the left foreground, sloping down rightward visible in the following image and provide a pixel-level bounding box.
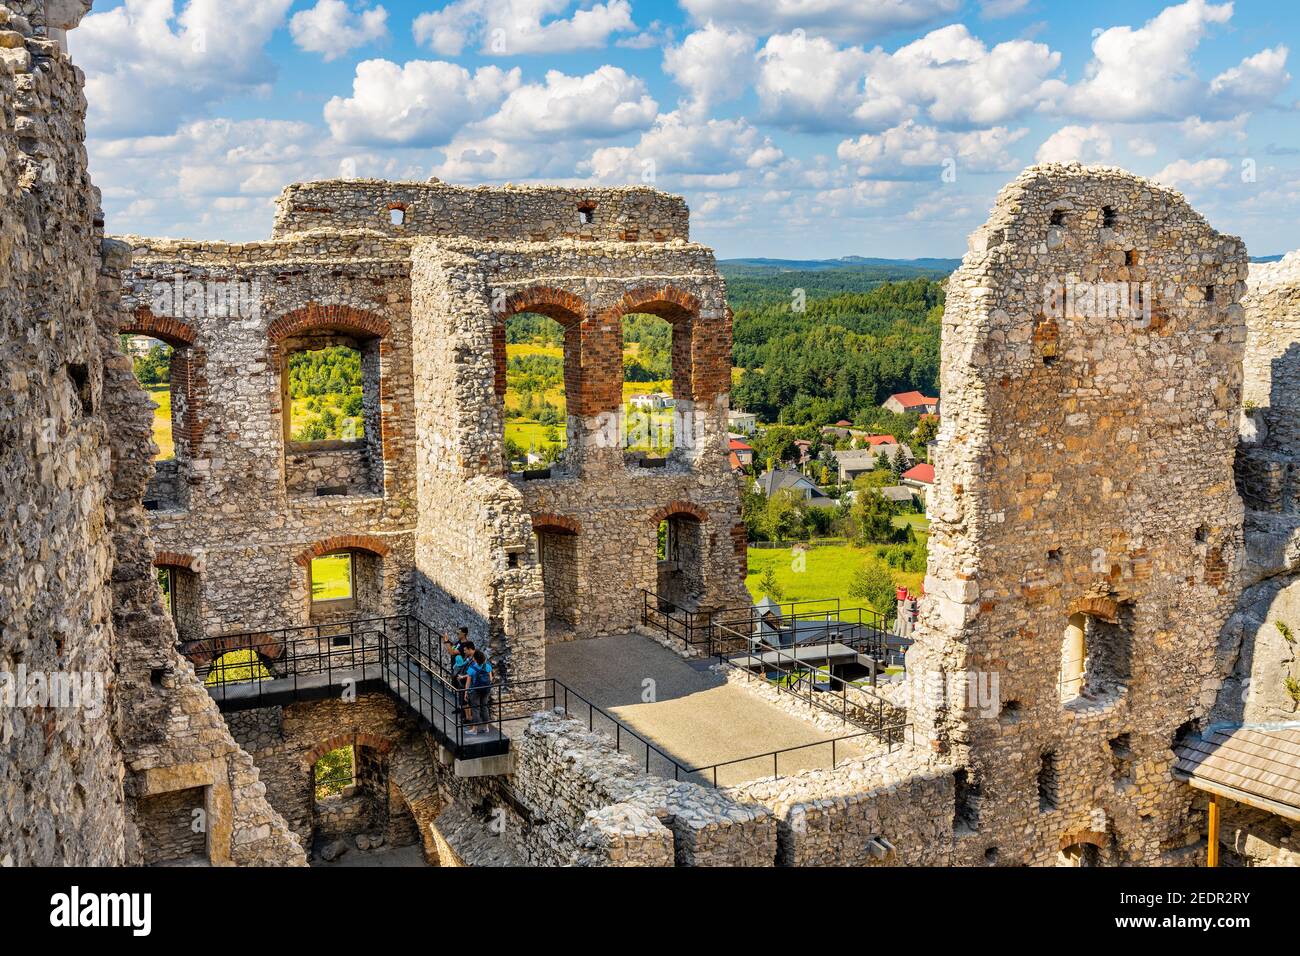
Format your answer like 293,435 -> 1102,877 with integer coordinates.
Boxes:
0,3 -> 303,865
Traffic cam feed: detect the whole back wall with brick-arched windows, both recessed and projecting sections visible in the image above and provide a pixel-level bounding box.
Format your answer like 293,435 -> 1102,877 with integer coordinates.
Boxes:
121,181 -> 748,679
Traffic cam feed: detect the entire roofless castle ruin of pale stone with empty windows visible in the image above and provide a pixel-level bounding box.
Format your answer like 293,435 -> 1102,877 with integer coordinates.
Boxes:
0,0 -> 1300,866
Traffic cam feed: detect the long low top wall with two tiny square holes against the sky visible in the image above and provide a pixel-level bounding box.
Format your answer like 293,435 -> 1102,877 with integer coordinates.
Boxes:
272,179 -> 690,242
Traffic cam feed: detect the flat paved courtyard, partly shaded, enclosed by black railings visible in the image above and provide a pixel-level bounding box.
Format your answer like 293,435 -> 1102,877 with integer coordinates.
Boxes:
546,633 -> 862,786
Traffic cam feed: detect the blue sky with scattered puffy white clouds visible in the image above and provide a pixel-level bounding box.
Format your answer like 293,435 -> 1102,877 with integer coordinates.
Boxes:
70,0 -> 1300,259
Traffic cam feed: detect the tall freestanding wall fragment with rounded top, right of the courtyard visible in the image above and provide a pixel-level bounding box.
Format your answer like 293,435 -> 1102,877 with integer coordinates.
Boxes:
909,165 -> 1247,864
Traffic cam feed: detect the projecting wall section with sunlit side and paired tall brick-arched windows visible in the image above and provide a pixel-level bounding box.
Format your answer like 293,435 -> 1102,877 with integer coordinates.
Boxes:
412,241 -> 749,676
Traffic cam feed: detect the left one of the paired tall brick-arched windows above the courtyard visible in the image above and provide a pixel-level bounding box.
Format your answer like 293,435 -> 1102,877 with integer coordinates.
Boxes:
503,312 -> 576,473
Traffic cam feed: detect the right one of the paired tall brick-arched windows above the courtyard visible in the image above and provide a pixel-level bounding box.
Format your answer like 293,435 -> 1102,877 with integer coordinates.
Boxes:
623,315 -> 677,459
